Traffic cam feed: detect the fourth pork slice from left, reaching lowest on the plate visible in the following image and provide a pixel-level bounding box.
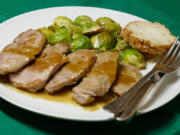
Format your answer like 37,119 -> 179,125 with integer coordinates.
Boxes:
73,51 -> 119,104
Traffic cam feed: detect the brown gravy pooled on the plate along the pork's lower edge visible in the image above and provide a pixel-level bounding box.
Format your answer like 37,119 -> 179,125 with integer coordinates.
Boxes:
0,76 -> 117,111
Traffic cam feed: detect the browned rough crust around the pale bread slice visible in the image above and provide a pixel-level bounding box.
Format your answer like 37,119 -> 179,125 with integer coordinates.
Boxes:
122,21 -> 176,54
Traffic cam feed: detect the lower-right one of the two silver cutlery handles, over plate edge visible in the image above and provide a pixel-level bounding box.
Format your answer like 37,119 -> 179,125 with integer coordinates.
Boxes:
115,77 -> 155,121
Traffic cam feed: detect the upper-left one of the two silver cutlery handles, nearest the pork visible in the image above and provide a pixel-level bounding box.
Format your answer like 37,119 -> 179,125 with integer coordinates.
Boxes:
104,69 -> 156,115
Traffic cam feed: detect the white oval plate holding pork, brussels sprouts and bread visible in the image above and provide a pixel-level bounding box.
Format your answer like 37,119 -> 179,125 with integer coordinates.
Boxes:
0,7 -> 180,121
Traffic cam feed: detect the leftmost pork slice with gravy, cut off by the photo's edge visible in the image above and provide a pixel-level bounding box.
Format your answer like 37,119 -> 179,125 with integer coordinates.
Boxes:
0,29 -> 45,75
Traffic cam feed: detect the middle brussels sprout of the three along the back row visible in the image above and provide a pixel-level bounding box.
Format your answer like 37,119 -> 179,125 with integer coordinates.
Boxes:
74,15 -> 93,27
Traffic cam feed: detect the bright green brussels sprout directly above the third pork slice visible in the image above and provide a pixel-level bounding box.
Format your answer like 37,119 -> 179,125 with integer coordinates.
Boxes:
71,34 -> 91,52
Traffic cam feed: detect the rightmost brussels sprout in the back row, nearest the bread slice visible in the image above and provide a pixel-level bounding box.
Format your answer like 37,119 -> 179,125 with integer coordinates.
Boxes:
96,17 -> 121,35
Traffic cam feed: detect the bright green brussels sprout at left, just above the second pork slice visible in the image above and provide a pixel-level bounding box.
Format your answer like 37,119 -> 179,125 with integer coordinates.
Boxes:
48,27 -> 72,44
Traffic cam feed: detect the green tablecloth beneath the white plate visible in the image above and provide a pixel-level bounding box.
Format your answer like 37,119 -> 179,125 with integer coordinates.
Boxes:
0,0 -> 180,135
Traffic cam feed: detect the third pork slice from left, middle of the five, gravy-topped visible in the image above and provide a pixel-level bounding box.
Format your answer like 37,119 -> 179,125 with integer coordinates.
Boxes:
45,49 -> 96,93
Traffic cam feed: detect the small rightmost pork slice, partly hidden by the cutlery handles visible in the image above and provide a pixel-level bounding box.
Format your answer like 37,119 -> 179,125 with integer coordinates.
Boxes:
111,63 -> 142,96
